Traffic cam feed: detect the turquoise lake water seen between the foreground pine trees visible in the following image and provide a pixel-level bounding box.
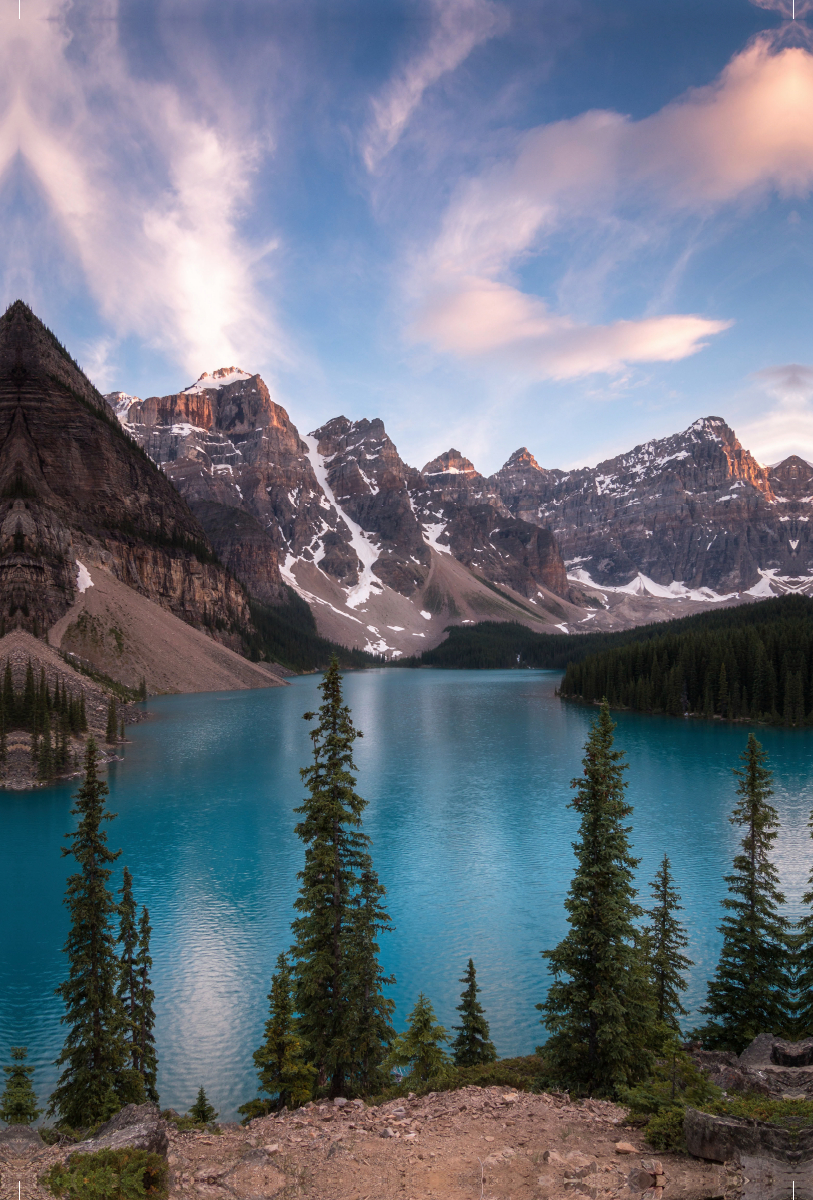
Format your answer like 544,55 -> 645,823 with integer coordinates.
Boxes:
0,670 -> 813,1120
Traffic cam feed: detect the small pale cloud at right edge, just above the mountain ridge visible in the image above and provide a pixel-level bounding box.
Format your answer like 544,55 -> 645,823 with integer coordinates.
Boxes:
737,362 -> 813,466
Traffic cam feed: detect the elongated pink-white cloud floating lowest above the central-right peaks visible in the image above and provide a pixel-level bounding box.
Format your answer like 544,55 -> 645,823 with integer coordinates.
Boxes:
411,277 -> 731,379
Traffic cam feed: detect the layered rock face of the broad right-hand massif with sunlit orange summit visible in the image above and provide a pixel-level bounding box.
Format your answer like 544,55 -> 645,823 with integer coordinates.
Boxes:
488,416 -> 813,594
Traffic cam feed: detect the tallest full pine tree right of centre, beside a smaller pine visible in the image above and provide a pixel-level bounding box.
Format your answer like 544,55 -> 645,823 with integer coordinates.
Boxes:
537,701 -> 657,1094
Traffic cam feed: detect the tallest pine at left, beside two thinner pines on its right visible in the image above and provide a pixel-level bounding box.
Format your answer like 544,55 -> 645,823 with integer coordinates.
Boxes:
48,737 -> 131,1128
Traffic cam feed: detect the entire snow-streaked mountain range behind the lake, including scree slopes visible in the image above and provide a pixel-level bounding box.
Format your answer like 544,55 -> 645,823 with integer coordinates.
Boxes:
106,367 -> 813,656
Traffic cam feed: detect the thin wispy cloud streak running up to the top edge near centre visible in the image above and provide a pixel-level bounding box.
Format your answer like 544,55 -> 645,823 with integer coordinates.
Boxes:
362,0 -> 506,173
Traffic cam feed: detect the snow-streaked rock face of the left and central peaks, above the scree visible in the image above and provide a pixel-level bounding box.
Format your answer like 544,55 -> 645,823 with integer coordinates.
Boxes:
107,388 -> 568,602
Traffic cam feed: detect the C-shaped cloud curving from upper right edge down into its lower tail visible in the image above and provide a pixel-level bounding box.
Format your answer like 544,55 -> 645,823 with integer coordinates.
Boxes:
411,35 -> 813,378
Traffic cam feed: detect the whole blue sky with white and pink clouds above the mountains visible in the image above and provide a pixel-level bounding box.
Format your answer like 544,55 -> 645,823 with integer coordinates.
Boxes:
0,0 -> 813,474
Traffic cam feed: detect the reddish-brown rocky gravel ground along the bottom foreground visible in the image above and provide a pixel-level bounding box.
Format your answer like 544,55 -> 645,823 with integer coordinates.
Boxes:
0,1087 -> 741,1200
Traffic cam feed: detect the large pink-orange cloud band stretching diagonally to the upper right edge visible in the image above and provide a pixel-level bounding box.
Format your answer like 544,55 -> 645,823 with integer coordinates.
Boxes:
424,36 -> 813,275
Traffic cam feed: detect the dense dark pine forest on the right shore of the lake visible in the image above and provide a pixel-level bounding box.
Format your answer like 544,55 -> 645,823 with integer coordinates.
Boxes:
560,596 -> 813,726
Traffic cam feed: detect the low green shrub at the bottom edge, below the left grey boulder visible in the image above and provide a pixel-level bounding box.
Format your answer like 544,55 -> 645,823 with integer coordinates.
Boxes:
41,1150 -> 168,1200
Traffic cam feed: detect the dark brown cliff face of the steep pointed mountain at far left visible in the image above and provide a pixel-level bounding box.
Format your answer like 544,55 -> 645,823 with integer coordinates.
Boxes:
0,301 -> 249,644
